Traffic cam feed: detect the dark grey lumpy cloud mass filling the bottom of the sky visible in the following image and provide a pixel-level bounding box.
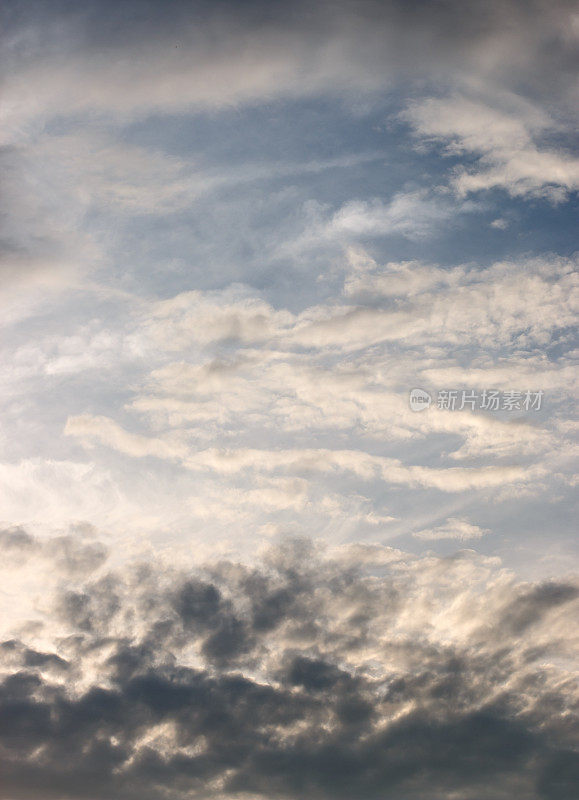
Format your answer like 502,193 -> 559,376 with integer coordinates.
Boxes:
0,531 -> 577,800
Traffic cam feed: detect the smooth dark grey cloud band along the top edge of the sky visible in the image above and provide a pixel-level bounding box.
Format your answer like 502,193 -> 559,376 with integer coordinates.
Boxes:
4,0 -> 575,126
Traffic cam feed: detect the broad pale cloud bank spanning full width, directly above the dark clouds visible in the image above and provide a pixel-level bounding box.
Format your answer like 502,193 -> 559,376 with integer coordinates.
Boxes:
0,248 -> 577,552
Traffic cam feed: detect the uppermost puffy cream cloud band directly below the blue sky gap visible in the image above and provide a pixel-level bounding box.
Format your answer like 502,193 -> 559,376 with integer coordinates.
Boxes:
134,250 -> 577,350
